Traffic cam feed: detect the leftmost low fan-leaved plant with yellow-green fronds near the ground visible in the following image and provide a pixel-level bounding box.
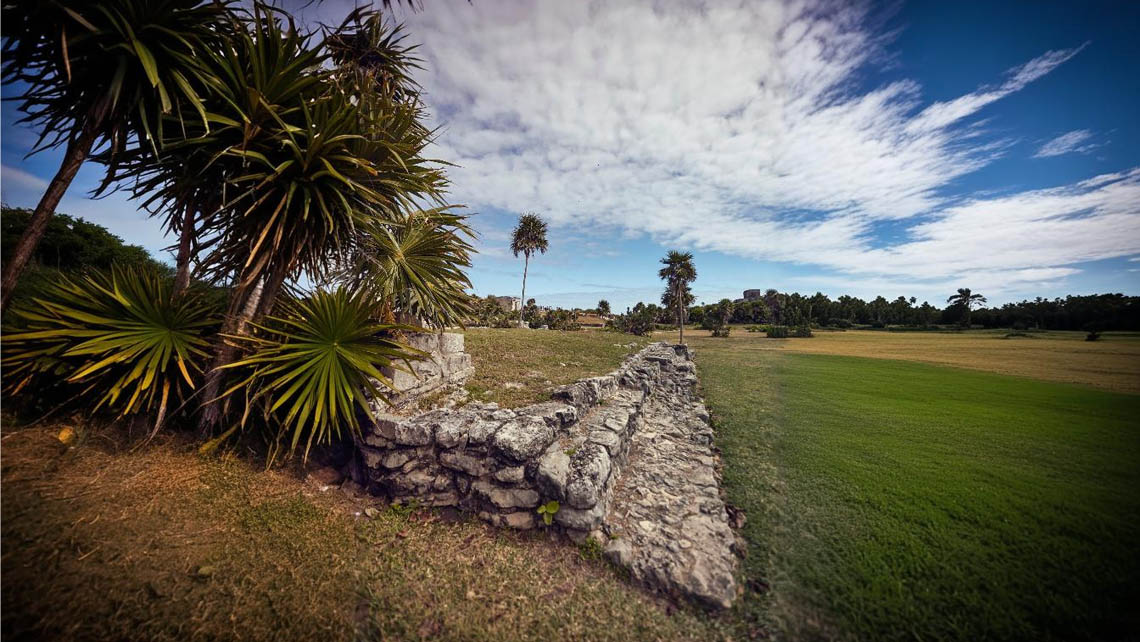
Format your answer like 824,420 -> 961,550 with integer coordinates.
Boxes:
0,266 -> 219,436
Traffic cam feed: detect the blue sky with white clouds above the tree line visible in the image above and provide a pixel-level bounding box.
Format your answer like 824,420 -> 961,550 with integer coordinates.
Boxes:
0,0 -> 1140,309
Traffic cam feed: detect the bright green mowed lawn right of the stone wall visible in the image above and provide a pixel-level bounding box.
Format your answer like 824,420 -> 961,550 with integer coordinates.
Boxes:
692,334 -> 1140,640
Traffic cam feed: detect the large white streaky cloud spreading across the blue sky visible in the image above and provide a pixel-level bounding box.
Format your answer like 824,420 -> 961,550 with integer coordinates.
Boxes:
371,0 -> 1112,291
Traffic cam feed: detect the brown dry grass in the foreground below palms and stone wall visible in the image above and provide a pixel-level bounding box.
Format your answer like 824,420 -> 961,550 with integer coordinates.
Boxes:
2,428 -> 722,640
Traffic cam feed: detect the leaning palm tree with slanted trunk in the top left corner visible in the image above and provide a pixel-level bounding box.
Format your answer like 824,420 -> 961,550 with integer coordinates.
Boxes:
0,0 -> 230,309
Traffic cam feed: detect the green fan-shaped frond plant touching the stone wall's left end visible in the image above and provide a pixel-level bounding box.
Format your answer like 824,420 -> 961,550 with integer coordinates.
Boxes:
222,287 -> 424,462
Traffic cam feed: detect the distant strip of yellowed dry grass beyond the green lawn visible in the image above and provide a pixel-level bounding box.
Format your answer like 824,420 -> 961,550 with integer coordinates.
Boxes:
662,327 -> 1140,393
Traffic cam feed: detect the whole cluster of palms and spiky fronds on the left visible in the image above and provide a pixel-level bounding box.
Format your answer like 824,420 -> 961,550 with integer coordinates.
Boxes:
3,0 -> 474,462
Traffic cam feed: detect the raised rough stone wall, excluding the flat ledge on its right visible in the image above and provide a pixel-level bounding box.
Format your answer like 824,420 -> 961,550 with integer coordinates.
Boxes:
361,343 -> 697,535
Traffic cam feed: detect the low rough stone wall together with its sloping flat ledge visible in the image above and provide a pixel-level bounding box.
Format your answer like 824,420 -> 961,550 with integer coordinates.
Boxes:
361,343 -> 736,608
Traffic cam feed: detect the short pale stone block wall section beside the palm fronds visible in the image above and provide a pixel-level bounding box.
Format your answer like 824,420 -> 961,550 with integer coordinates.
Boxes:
381,332 -> 474,408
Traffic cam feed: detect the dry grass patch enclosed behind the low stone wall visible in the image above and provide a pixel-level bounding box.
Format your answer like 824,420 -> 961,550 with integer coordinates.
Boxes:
465,328 -> 650,408
